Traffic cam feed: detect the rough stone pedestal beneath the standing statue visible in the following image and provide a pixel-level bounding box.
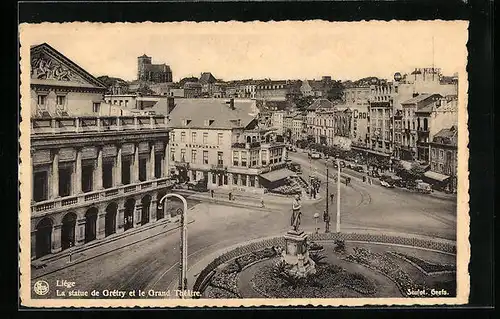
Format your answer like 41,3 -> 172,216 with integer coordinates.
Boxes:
282,230 -> 316,277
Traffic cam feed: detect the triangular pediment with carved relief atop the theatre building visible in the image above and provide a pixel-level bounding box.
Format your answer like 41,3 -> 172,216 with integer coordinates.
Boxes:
31,43 -> 105,89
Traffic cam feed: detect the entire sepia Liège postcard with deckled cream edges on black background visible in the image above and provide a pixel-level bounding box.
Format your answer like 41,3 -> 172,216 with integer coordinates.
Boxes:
19,20 -> 470,308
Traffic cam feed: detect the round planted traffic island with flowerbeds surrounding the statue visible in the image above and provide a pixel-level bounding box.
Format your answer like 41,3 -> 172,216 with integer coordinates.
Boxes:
194,234 -> 456,298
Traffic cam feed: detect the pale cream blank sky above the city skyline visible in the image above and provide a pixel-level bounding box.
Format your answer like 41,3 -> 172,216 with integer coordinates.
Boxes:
20,21 -> 467,81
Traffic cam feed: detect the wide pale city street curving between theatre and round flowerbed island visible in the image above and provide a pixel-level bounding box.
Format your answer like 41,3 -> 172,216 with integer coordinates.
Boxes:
32,153 -> 456,298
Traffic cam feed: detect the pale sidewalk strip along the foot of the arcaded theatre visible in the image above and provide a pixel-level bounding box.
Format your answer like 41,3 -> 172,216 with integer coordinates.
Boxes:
31,216 -> 194,280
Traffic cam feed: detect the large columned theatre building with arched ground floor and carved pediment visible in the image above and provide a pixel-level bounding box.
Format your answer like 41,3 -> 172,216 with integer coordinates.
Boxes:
30,44 -> 171,259
